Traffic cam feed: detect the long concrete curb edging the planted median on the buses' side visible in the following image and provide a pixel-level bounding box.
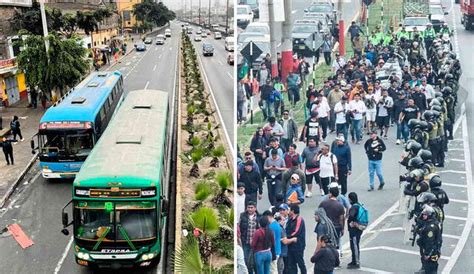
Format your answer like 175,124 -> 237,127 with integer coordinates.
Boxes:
173,34 -> 183,270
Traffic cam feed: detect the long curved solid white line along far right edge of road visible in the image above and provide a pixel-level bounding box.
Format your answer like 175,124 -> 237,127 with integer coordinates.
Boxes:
442,113 -> 474,273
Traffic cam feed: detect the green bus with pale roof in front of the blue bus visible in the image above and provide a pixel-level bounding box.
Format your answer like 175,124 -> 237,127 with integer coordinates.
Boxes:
62,90 -> 172,269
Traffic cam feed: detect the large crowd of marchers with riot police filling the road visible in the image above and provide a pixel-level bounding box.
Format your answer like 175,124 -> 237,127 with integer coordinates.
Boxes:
236,18 -> 461,274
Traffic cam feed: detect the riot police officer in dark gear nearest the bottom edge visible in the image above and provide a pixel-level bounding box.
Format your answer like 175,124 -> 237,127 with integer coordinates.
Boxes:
417,217 -> 442,274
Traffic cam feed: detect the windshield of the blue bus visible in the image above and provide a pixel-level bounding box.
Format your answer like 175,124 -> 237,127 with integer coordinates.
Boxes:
39,130 -> 94,162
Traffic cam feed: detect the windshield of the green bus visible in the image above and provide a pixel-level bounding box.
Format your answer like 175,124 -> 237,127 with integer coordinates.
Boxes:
74,201 -> 157,244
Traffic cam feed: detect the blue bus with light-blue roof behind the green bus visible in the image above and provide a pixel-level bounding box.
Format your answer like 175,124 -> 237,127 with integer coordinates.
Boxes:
31,71 -> 124,178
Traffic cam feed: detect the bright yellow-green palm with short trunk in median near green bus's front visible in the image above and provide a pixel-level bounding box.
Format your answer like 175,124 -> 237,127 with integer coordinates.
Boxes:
188,207 -> 220,262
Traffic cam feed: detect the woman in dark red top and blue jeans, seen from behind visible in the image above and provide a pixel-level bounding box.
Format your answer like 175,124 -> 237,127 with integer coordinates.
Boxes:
251,218 -> 275,274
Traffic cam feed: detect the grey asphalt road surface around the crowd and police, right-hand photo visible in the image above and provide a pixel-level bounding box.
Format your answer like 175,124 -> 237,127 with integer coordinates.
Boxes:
252,1 -> 474,273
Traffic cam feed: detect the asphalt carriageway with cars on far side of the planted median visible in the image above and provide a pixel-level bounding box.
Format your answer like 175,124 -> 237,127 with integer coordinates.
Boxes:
191,34 -> 236,150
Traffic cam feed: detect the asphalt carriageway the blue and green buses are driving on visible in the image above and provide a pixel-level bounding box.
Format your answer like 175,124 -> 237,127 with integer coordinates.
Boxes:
0,24 -> 180,274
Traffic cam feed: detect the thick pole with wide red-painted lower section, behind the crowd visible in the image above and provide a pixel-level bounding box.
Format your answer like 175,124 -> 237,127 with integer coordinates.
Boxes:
281,0 -> 293,82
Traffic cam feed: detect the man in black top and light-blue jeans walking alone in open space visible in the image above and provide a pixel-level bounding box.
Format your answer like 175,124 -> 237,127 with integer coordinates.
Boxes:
364,130 -> 387,191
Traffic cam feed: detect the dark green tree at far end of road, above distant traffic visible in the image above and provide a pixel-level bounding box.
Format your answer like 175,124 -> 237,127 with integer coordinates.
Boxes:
133,0 -> 176,27
